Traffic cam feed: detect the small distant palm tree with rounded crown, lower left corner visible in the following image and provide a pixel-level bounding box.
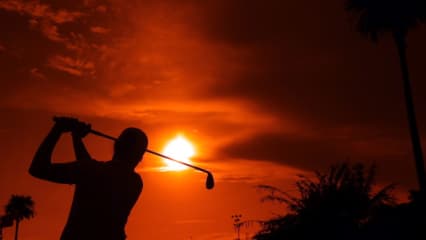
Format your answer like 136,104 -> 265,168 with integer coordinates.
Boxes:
5,195 -> 34,240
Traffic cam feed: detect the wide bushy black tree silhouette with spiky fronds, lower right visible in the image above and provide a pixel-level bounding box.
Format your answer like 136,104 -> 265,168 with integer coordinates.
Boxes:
254,164 -> 394,240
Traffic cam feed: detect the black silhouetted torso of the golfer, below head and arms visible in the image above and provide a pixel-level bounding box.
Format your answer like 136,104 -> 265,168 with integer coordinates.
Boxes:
61,163 -> 142,240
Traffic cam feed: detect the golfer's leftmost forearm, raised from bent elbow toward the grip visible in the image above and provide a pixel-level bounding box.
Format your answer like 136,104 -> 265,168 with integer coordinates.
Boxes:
29,125 -> 62,179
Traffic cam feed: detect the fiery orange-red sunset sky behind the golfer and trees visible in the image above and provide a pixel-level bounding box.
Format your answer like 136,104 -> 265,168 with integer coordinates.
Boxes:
0,0 -> 426,240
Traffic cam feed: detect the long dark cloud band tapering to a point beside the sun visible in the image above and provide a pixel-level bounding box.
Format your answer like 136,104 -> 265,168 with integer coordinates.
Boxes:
218,133 -> 416,186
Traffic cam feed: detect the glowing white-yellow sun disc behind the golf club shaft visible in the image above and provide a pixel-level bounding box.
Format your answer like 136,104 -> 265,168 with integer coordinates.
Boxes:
163,135 -> 195,171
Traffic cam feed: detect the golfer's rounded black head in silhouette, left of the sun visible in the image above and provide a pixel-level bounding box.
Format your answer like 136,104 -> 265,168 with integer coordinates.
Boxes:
114,128 -> 148,167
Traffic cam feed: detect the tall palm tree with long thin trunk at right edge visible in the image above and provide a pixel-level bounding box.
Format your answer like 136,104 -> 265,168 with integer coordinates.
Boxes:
346,0 -> 426,193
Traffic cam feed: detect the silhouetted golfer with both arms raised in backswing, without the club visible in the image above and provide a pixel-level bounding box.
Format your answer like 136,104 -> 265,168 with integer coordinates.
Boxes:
29,117 -> 148,240
